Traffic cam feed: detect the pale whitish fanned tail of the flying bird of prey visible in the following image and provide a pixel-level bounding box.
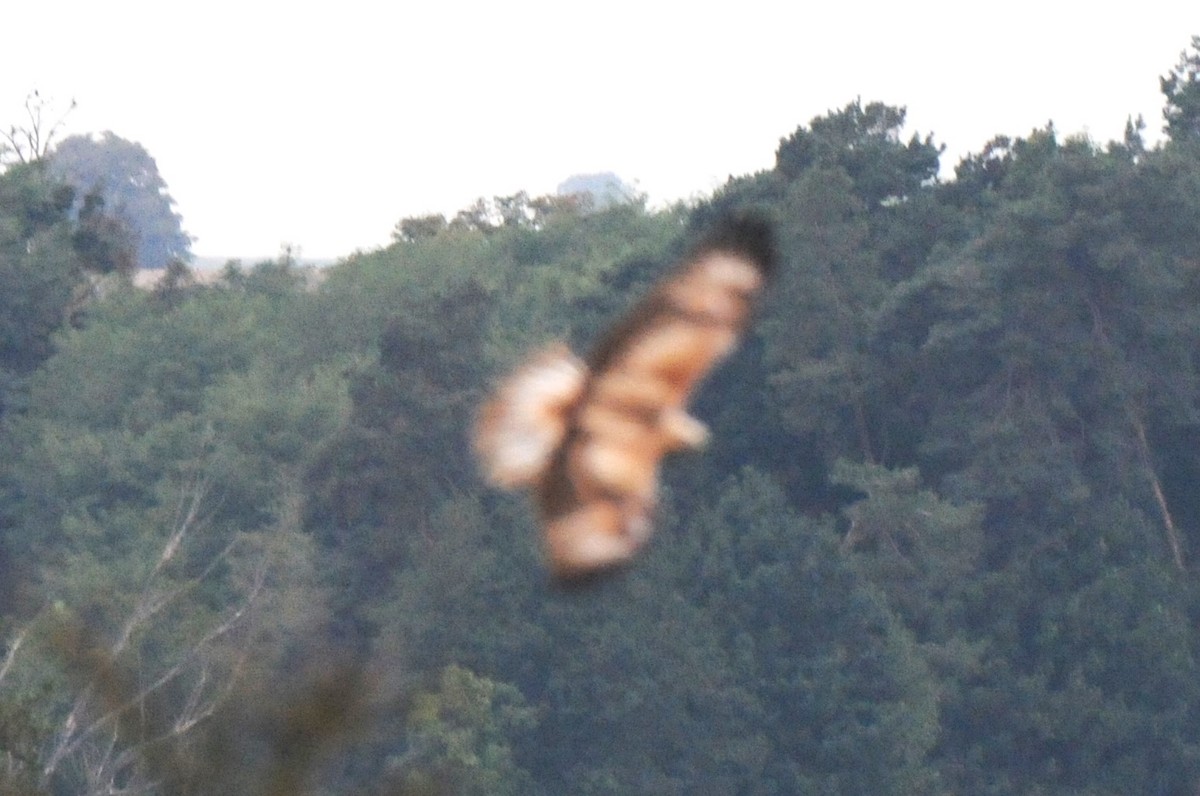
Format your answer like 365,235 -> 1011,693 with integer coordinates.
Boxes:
474,345 -> 587,489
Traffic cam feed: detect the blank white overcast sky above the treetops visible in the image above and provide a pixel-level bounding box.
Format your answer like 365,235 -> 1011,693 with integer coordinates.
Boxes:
0,0 -> 1200,258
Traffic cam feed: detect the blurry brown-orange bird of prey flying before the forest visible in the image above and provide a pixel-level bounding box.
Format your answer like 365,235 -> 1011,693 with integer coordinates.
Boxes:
474,215 -> 776,579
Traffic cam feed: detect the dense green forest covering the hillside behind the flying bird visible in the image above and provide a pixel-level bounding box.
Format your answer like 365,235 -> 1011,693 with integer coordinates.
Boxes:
0,37 -> 1200,796
